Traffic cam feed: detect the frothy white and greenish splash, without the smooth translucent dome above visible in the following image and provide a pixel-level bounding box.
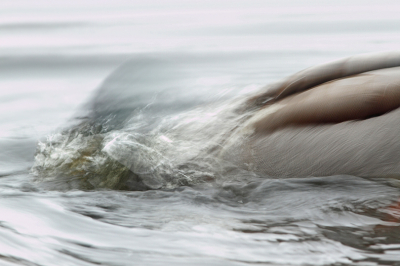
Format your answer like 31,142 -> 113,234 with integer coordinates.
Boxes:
31,94 -> 256,190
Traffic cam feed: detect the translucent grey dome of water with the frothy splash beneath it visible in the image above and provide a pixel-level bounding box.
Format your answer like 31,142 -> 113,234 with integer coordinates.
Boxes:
31,58 -> 254,190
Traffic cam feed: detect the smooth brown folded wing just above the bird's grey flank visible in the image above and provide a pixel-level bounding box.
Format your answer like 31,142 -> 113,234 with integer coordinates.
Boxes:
254,67 -> 400,132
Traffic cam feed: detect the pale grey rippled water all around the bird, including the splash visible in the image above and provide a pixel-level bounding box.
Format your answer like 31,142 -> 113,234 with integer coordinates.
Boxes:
0,0 -> 400,265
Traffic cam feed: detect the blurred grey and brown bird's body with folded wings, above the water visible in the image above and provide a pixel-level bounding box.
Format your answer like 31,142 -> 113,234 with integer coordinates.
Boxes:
222,53 -> 400,177
